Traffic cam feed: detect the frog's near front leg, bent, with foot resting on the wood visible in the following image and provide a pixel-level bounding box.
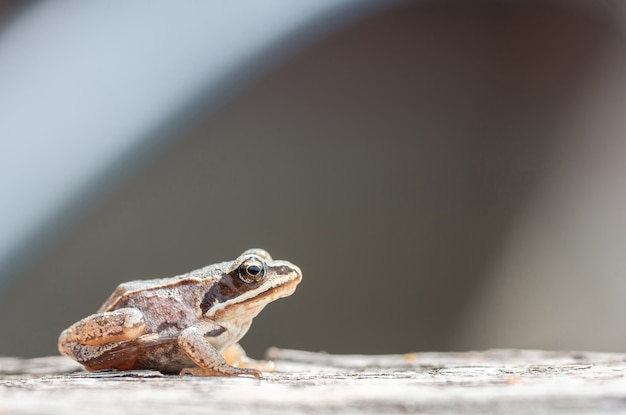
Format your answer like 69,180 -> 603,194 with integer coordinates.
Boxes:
178,321 -> 261,378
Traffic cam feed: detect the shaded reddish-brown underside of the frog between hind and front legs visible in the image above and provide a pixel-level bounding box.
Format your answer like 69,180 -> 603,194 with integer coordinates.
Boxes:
81,337 -> 196,374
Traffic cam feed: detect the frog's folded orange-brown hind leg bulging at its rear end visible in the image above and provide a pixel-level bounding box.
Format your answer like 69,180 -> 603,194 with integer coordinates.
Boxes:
58,308 -> 146,363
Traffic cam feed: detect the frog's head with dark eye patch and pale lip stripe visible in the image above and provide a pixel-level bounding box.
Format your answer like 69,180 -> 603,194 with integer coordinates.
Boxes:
200,249 -> 302,321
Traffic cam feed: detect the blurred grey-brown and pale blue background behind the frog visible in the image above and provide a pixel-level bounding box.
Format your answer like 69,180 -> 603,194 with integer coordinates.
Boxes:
0,0 -> 626,357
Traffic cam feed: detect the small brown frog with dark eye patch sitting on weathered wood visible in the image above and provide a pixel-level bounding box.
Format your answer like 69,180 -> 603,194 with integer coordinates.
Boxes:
58,248 -> 302,378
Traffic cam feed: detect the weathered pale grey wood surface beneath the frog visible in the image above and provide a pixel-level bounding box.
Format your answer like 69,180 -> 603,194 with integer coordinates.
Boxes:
0,349 -> 626,415
